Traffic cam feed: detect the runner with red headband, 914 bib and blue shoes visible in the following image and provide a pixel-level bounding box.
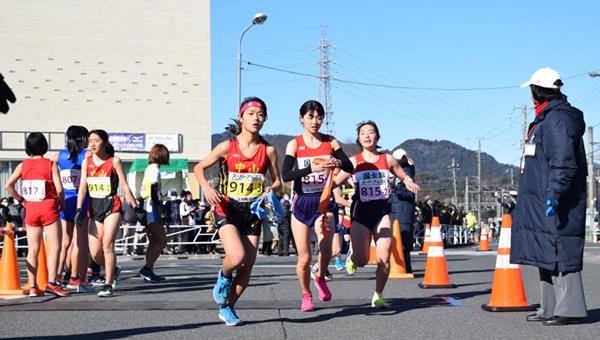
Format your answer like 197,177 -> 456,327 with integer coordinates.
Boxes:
194,97 -> 281,326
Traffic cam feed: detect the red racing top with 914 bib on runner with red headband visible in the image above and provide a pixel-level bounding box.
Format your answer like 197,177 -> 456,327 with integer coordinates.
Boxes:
217,138 -> 269,216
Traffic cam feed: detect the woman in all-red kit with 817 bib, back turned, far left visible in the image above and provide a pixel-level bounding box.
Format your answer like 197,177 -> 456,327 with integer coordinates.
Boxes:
5,132 -> 69,296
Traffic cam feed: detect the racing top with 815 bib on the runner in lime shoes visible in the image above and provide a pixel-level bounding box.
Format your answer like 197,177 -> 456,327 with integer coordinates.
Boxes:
354,153 -> 390,202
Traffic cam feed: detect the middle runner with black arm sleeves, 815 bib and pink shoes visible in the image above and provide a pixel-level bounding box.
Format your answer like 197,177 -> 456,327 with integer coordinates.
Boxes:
282,100 -> 353,312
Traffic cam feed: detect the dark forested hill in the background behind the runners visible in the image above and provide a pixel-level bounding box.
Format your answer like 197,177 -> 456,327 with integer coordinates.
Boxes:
208,132 -> 518,201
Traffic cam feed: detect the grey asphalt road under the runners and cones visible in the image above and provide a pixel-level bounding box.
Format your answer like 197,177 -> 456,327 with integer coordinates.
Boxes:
0,245 -> 600,340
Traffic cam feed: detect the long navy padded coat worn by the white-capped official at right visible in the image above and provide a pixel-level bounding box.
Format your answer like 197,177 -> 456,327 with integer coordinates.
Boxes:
510,97 -> 587,272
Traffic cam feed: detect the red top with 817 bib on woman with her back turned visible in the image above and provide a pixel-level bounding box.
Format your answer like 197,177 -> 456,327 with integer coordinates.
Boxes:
21,158 -> 58,203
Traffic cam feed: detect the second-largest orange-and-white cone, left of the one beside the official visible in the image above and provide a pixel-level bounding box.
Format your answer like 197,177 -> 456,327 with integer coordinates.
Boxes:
419,217 -> 456,289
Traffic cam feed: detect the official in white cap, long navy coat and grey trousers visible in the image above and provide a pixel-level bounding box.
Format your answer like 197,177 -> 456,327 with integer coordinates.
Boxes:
510,68 -> 588,325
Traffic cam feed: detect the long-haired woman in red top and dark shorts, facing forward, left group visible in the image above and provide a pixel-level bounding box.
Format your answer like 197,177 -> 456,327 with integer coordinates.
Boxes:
75,130 -> 137,297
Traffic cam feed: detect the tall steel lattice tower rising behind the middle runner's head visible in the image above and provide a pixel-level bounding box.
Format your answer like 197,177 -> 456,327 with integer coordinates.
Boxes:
318,26 -> 335,135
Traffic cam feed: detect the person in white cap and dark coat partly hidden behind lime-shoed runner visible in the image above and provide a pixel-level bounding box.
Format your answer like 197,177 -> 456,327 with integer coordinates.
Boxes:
390,149 -> 416,273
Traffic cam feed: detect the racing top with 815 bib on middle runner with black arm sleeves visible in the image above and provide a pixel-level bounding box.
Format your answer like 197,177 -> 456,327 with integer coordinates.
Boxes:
294,134 -> 333,195
